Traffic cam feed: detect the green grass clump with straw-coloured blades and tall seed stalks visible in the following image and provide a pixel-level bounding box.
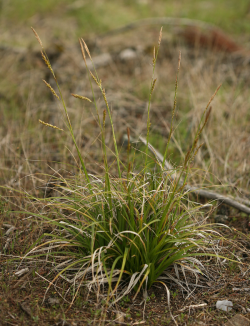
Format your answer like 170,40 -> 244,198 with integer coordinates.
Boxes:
19,26 -> 223,304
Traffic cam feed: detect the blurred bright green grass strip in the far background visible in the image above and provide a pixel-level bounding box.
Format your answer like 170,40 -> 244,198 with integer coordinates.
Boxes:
0,0 -> 250,43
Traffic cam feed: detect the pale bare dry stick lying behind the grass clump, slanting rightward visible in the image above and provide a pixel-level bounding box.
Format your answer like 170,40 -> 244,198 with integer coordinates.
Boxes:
139,136 -> 250,214
